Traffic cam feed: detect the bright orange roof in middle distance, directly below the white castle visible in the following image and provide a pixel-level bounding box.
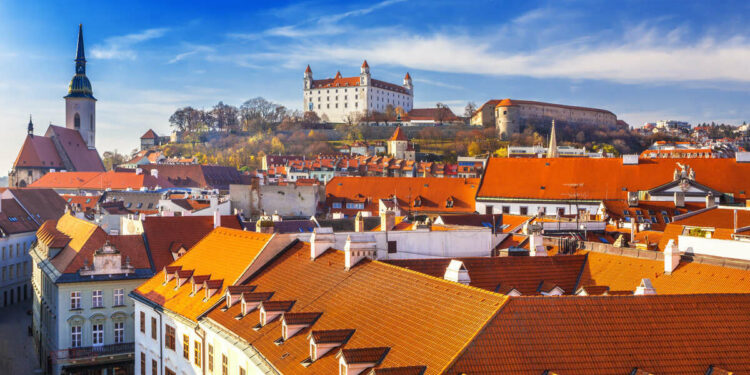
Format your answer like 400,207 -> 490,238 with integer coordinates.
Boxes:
326,176 -> 479,213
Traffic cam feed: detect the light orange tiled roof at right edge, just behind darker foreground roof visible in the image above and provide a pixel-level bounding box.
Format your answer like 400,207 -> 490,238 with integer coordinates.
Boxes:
579,251 -> 750,294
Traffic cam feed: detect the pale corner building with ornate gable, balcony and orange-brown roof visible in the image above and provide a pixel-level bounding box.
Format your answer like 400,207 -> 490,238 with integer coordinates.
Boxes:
30,213 -> 172,374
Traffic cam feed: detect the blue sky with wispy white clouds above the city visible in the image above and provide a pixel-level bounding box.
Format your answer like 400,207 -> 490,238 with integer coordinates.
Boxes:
0,0 -> 750,169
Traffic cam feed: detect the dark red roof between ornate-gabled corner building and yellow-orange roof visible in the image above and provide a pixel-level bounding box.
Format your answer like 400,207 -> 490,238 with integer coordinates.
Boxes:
143,215 -> 242,270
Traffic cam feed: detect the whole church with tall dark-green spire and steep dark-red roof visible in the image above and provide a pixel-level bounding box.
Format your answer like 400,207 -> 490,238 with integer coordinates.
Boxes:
8,25 -> 104,187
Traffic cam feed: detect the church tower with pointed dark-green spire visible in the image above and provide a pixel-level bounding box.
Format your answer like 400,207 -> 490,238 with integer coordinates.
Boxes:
65,25 -> 96,149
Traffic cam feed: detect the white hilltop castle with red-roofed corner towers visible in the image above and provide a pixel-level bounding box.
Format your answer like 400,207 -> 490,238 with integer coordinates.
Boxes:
303,61 -> 414,123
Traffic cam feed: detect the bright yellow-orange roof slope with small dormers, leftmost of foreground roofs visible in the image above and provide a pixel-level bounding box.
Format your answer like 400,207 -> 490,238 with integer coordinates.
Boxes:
133,227 -> 274,321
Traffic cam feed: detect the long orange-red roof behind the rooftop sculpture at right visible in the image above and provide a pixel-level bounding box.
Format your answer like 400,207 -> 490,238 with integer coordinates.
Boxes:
477,158 -> 750,200
